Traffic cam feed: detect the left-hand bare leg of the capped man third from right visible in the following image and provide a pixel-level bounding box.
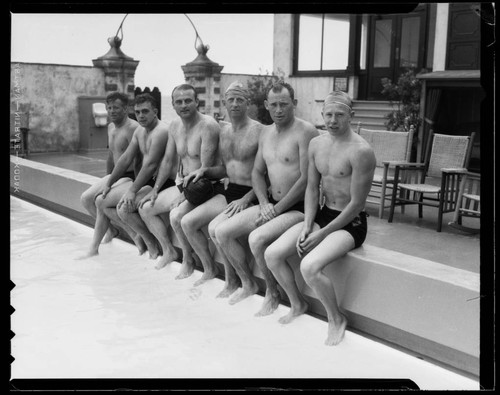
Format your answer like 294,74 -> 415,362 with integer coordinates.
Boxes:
181,195 -> 227,286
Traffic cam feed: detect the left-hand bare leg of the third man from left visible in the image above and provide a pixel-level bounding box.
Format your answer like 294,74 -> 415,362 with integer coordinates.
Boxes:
139,186 -> 180,269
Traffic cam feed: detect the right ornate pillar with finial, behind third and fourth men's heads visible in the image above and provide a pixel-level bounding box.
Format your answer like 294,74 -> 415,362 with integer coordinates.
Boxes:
181,44 -> 224,119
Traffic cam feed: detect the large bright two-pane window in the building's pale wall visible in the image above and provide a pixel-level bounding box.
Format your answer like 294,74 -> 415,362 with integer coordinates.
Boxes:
296,14 -> 350,72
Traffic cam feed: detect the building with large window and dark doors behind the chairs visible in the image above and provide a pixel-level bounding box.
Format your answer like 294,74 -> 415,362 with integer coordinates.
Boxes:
273,3 -> 483,170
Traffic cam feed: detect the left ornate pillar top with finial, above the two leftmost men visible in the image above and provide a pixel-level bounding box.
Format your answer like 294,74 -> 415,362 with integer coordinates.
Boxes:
92,36 -> 139,99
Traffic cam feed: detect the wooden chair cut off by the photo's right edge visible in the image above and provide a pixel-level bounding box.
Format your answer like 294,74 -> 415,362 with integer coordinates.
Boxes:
448,171 -> 481,233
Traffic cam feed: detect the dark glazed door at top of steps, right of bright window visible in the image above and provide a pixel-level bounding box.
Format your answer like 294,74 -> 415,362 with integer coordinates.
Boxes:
367,10 -> 425,100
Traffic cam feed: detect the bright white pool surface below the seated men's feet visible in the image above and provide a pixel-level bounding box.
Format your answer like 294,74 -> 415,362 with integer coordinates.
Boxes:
10,197 -> 479,390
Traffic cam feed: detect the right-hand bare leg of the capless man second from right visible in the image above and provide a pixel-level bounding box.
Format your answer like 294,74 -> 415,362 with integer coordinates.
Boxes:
248,211 -> 304,317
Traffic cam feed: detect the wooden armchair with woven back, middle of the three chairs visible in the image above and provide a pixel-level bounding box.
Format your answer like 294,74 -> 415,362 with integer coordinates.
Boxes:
389,131 -> 474,232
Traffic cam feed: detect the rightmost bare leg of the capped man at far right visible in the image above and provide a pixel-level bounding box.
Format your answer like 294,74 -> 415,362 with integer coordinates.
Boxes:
300,230 -> 354,346
